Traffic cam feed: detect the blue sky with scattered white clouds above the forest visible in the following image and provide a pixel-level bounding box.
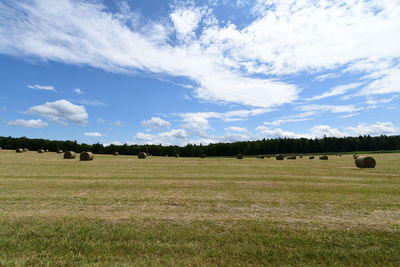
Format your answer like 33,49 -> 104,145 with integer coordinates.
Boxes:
0,0 -> 400,145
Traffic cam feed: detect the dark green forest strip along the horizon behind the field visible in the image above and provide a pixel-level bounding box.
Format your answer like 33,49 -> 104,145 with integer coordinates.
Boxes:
0,135 -> 400,157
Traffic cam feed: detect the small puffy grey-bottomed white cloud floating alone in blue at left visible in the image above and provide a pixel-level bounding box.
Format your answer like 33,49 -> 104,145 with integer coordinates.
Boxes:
26,99 -> 89,125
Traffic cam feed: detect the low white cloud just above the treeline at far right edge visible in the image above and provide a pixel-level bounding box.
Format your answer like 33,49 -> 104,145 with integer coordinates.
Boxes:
346,121 -> 400,136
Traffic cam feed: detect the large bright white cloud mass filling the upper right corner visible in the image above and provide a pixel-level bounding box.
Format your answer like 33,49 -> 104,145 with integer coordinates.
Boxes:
202,0 -> 400,97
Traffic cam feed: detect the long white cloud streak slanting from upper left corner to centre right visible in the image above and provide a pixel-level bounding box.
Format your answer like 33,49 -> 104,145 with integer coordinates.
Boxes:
0,0 -> 299,107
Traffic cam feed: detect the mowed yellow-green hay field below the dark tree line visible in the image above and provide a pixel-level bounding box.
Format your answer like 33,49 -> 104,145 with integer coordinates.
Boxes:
0,150 -> 400,266
